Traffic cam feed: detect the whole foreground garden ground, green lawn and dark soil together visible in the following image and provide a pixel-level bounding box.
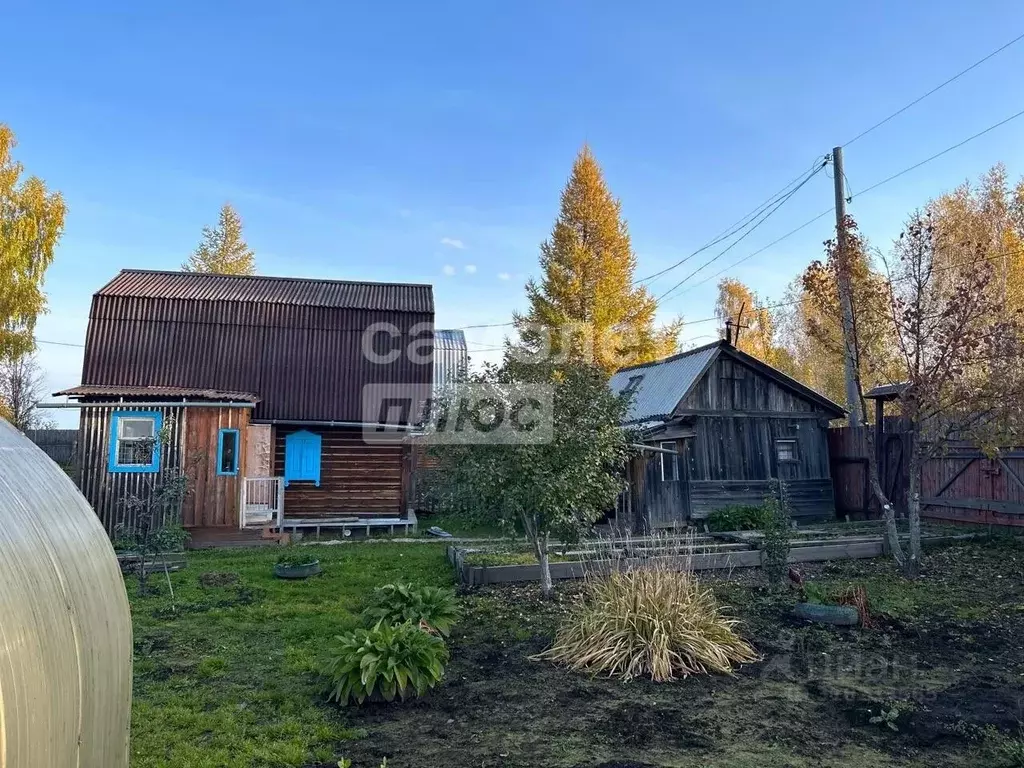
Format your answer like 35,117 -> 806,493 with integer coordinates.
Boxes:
129,540 -> 1024,768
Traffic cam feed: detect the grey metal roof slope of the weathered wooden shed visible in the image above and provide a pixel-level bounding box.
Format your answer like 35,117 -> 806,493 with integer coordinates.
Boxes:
608,342 -> 723,423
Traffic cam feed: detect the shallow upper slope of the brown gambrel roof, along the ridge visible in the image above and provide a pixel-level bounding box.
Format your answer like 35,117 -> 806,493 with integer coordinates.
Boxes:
96,269 -> 434,312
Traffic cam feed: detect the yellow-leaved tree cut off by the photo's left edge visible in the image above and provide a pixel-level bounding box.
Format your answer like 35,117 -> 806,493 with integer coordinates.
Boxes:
0,123 -> 67,359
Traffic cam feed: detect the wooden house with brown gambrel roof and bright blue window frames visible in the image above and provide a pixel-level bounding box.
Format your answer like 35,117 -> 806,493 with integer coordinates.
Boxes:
56,269 -> 434,532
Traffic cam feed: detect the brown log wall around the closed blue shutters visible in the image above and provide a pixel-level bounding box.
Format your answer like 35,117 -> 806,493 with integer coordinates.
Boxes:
273,426 -> 408,517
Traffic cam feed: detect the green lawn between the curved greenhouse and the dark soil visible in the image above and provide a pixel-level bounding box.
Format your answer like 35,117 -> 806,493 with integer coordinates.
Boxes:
127,544 -> 452,768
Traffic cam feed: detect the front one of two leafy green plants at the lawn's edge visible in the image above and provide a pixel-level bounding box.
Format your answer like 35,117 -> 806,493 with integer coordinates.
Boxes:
321,624 -> 449,705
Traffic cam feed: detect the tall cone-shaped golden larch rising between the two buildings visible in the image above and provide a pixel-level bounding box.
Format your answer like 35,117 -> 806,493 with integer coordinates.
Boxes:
515,145 -> 682,373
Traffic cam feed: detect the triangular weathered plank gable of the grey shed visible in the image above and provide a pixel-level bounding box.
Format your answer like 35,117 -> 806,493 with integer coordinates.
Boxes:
675,354 -> 824,415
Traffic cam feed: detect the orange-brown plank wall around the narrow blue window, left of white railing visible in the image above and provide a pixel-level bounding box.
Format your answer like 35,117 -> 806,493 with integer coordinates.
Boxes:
182,408 -> 249,527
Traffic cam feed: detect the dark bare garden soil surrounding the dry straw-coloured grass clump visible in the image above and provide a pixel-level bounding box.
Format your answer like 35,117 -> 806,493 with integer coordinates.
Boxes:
323,540 -> 1024,768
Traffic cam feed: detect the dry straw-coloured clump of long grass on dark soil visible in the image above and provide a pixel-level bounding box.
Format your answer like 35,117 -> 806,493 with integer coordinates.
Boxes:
538,563 -> 758,682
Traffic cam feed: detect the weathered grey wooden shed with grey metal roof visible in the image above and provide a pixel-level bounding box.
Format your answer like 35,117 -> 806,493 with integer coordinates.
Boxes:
610,340 -> 846,530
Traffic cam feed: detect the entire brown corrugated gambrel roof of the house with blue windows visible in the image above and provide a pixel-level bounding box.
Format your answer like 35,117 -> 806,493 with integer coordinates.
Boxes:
74,269 -> 434,422
